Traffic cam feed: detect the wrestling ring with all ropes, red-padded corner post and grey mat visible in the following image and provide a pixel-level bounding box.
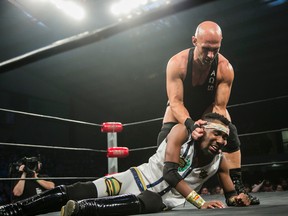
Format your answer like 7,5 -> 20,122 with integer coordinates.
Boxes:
0,0 -> 288,216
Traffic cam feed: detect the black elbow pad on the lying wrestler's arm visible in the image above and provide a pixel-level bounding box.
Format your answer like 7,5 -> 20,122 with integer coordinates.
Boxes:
163,161 -> 182,187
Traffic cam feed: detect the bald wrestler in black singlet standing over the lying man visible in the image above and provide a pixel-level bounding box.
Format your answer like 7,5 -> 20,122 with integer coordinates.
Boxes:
158,21 -> 260,205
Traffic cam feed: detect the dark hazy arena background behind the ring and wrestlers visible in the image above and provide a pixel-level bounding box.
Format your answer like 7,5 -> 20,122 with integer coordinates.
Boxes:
0,0 -> 288,202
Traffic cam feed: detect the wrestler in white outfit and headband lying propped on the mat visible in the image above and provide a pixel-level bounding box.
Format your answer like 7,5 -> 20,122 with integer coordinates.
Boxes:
0,113 -> 250,216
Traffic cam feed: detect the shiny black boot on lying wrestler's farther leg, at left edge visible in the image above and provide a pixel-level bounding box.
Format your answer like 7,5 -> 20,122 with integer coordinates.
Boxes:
0,186 -> 68,216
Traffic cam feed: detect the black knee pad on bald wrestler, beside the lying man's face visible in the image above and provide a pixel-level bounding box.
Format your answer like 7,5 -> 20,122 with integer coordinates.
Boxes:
222,123 -> 241,153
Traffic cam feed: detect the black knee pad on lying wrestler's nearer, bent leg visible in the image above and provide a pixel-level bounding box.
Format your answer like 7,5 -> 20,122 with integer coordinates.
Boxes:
137,190 -> 165,214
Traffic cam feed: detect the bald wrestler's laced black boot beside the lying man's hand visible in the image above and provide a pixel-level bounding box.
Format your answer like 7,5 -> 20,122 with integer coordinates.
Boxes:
229,168 -> 260,205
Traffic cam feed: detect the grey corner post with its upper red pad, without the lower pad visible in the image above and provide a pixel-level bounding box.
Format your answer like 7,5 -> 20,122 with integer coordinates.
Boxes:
101,122 -> 123,174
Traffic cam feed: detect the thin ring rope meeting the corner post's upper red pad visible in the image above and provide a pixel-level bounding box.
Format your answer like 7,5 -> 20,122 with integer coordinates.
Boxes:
0,95 -> 288,127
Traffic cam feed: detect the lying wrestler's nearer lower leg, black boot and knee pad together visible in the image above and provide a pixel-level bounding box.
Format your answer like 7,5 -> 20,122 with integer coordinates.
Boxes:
61,191 -> 164,216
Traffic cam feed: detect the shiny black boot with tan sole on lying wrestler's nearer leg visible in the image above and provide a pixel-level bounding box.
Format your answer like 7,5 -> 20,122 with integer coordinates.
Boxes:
61,194 -> 142,216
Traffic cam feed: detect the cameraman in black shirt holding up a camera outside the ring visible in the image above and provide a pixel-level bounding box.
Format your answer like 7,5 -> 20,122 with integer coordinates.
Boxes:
12,157 -> 55,202
